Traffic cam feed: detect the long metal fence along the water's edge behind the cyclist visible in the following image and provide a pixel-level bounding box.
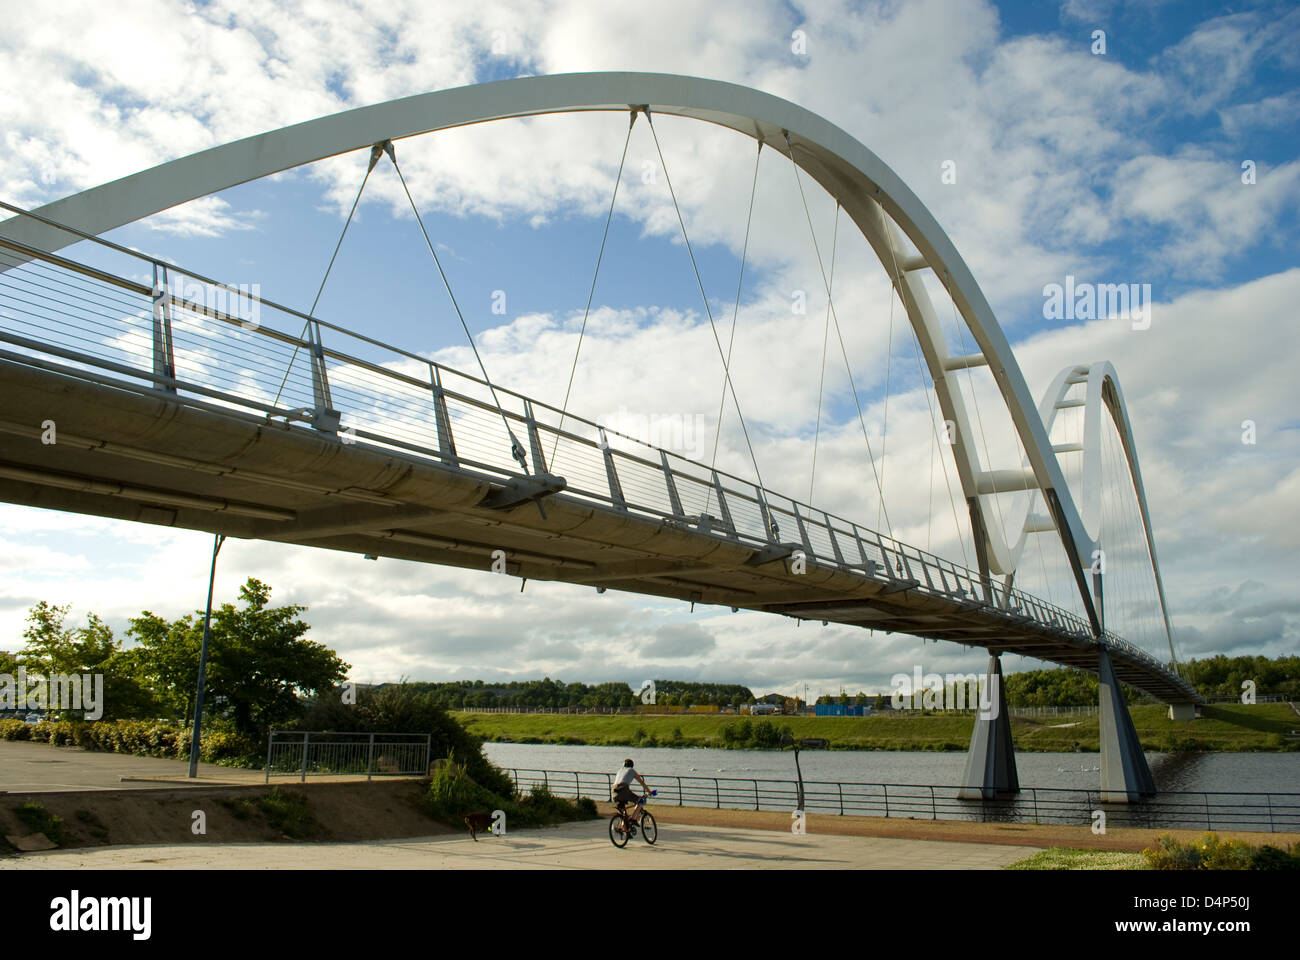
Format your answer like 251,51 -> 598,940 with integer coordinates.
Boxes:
508,767 -> 1300,833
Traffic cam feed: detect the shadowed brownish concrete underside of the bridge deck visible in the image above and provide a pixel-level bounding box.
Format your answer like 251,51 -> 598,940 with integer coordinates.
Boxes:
0,360 -> 1187,702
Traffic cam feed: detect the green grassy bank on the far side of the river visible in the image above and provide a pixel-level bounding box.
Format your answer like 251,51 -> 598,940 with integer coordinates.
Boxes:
454,704 -> 1300,752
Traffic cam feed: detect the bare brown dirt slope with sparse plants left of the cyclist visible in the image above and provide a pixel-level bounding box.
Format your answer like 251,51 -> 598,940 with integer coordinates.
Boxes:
0,779 -> 455,847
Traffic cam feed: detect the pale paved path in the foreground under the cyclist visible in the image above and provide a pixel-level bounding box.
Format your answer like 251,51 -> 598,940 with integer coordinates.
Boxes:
0,820 -> 1039,870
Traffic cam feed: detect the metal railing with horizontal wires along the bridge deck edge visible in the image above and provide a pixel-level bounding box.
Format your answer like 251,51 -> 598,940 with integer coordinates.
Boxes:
0,204 -> 1196,700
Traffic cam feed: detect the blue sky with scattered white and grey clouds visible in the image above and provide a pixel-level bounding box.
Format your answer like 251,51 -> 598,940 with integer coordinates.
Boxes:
0,0 -> 1300,696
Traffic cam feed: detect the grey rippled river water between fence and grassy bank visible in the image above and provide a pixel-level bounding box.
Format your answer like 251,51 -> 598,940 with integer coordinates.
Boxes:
484,743 -> 1300,793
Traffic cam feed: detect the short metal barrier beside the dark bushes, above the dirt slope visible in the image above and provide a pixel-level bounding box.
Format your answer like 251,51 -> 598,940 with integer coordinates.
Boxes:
267,730 -> 430,783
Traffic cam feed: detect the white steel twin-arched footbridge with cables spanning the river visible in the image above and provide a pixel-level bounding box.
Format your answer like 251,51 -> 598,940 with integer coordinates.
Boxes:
0,73 -> 1199,799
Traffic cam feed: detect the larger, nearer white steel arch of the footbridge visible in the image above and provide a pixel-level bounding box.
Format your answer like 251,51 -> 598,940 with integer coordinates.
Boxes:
0,73 -> 1101,633
